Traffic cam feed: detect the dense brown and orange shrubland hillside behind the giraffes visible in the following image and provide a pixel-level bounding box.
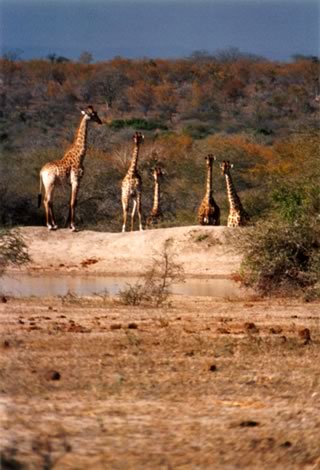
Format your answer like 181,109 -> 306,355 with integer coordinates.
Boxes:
0,53 -> 319,231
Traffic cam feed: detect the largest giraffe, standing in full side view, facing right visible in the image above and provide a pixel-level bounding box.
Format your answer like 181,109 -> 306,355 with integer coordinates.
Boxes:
38,106 -> 102,232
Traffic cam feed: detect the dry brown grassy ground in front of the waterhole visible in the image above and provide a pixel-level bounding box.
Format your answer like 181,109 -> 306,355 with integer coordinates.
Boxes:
0,298 -> 320,470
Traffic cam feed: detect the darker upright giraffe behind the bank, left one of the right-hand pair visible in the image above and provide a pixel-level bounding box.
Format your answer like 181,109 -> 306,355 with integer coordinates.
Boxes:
198,154 -> 220,225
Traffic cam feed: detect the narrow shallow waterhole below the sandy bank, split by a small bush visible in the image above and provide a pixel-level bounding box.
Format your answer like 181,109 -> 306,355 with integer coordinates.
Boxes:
0,273 -> 248,299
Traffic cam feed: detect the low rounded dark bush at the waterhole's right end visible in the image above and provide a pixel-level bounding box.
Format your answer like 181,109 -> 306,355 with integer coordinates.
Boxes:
238,218 -> 320,295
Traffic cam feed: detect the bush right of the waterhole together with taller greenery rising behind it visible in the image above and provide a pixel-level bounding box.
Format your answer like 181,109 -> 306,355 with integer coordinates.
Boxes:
238,134 -> 320,300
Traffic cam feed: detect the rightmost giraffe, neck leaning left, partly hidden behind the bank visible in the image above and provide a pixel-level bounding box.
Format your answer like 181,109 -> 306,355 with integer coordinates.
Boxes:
220,161 -> 249,227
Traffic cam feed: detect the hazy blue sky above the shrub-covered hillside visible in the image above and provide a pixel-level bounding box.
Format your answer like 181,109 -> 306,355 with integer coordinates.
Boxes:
0,0 -> 319,60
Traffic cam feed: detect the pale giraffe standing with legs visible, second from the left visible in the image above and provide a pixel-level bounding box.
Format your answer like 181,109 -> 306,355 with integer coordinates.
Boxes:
121,132 -> 144,232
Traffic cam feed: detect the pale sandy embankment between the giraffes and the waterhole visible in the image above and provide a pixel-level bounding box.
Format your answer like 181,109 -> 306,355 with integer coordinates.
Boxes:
13,226 -> 241,278
